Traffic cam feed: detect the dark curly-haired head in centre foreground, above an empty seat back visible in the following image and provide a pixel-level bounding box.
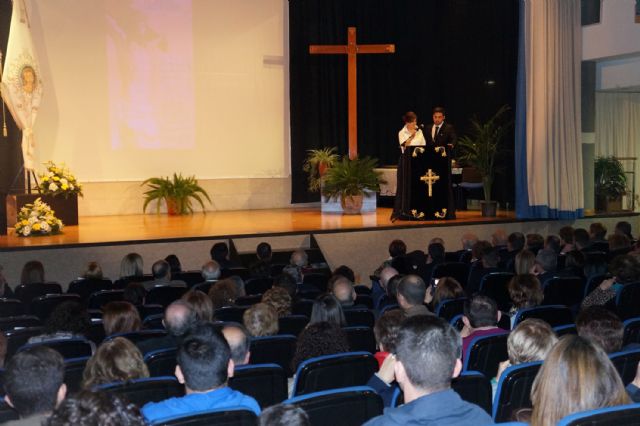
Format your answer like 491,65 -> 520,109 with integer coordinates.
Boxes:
291,322 -> 349,371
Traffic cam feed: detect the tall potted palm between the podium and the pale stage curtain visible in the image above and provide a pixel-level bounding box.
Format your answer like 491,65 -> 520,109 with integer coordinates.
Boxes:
458,105 -> 512,201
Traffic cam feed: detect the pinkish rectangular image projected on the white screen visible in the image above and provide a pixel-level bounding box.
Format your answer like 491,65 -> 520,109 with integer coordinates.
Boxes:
104,0 -> 195,150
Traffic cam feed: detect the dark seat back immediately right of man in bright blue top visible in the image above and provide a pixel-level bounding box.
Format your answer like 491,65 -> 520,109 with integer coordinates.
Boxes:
229,364 -> 288,408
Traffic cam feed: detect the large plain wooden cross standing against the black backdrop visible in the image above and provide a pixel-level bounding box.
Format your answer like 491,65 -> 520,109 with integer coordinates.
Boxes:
309,27 -> 396,160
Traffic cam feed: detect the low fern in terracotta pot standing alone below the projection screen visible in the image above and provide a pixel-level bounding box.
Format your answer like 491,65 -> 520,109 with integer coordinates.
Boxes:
142,173 -> 211,214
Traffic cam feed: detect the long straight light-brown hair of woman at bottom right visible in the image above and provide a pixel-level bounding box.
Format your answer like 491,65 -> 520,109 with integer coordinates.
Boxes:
531,335 -> 631,426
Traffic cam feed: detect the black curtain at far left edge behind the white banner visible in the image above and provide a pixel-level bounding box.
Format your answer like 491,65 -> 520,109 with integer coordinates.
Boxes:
0,0 -> 24,193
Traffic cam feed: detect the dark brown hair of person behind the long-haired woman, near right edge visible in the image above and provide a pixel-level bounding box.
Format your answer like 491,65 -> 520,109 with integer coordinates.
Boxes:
576,306 -> 624,354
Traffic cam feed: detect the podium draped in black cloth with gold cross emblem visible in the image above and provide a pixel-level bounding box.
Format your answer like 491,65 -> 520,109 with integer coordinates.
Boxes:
391,145 -> 456,220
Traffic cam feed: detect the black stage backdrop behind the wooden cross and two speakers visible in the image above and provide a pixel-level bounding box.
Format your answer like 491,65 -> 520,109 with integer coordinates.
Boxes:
289,0 -> 518,203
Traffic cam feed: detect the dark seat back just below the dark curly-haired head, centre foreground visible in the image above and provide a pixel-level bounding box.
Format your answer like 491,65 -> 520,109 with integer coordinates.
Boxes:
293,352 -> 378,396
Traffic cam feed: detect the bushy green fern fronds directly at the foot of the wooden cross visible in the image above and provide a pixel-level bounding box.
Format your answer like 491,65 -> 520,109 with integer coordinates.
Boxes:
322,156 -> 386,200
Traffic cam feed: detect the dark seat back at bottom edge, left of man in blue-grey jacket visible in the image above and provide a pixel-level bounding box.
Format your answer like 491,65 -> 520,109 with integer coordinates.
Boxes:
284,386 -> 383,425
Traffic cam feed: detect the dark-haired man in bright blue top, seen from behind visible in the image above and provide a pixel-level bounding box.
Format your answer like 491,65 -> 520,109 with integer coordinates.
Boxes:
142,323 -> 260,422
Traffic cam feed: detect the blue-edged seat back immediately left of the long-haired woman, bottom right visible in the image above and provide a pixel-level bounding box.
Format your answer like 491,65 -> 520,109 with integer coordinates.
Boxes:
493,362 -> 542,422
